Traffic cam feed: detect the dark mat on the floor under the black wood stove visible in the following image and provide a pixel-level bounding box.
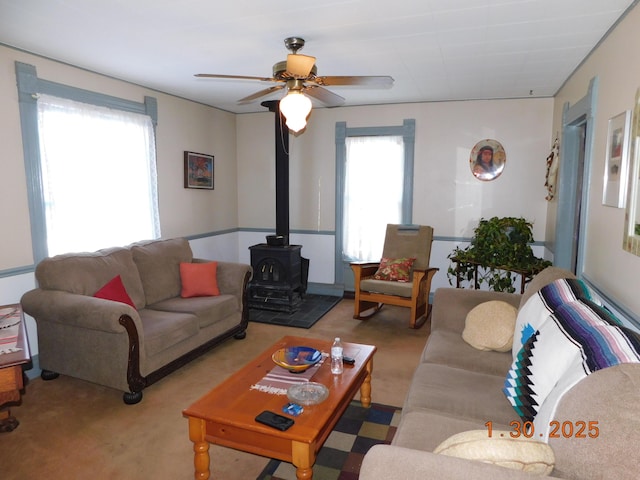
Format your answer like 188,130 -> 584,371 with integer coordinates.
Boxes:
249,294 -> 342,328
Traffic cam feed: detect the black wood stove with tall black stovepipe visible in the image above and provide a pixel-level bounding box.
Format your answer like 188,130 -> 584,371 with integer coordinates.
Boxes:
248,100 -> 309,313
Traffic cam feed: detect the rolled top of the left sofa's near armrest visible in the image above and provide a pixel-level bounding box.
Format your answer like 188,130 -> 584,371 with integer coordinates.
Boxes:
20,288 -> 142,333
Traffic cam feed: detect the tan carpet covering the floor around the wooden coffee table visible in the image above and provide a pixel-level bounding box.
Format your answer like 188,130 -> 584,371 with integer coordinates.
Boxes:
0,300 -> 429,480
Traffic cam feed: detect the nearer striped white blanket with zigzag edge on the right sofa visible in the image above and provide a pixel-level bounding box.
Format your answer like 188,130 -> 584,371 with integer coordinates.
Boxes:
503,299 -> 640,441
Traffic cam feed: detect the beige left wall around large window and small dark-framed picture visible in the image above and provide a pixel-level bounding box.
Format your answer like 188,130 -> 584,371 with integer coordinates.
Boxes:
0,46 -> 238,271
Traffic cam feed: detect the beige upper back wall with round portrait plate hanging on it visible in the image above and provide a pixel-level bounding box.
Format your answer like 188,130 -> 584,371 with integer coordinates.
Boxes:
237,99 -> 553,241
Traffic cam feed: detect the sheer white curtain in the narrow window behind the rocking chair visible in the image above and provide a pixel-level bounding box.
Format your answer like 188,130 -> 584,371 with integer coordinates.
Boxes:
342,135 -> 404,261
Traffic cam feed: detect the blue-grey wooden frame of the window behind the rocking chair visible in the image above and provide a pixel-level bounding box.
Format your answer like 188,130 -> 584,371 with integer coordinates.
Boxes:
335,118 -> 416,285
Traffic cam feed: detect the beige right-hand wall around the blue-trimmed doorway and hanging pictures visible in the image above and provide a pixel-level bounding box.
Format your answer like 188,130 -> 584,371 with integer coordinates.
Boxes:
547,3 -> 640,315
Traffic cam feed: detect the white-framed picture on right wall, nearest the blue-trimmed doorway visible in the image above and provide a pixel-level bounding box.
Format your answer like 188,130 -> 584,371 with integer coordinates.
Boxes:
602,110 -> 631,208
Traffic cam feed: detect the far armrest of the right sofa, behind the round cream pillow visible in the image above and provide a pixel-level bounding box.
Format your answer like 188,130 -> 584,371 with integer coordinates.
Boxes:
431,287 -> 521,333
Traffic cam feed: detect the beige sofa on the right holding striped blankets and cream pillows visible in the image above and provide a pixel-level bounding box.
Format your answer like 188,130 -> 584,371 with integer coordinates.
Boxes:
360,267 -> 640,480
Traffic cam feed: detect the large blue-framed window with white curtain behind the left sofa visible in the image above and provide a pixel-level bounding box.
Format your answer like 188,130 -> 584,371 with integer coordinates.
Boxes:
15,62 -> 160,263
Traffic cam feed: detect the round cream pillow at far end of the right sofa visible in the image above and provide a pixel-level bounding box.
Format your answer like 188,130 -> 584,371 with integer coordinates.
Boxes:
462,300 -> 518,352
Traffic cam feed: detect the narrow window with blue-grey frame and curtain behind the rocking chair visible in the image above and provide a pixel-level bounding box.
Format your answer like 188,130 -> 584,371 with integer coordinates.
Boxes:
335,119 -> 415,290
